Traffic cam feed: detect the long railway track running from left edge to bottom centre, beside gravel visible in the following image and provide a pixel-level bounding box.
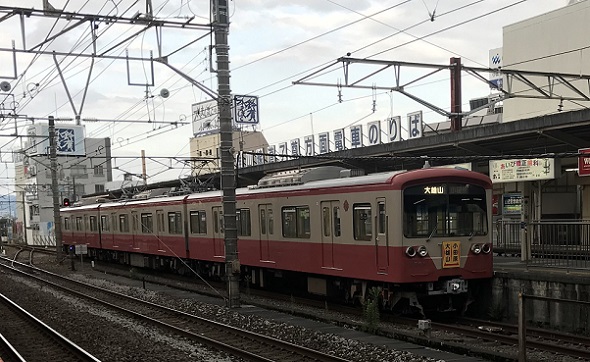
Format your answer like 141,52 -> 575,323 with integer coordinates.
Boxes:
4,263 -> 347,362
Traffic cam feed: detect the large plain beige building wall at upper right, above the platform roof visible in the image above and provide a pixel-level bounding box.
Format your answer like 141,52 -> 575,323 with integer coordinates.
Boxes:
503,1 -> 590,122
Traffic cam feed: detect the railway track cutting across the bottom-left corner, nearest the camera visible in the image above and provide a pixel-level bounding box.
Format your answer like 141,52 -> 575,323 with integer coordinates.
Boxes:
0,294 -> 100,362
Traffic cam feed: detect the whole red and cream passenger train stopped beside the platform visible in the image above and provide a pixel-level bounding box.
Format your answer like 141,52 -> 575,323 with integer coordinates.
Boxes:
61,167 -> 492,307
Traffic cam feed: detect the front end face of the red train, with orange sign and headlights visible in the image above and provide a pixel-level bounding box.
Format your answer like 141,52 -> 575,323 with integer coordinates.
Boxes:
383,168 -> 493,312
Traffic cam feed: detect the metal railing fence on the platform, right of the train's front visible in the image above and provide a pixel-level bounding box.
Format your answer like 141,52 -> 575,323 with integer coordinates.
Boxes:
493,219 -> 590,269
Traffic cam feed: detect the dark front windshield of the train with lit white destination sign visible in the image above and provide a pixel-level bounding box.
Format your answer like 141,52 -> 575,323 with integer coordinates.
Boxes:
403,183 -> 488,238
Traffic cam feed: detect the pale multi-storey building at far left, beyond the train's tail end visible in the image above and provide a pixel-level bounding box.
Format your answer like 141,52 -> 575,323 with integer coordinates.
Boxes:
15,125 -> 113,245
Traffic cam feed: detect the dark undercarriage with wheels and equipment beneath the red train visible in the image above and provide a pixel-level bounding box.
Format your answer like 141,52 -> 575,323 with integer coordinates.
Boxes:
88,249 -> 485,316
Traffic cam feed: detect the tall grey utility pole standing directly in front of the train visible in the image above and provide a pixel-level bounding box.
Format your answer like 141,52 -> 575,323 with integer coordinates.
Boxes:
212,0 -> 240,308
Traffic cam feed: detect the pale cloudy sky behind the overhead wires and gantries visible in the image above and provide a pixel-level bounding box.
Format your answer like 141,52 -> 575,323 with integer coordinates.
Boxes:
0,0 -> 569,194
